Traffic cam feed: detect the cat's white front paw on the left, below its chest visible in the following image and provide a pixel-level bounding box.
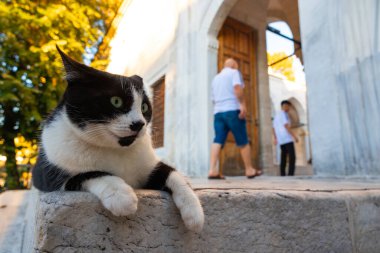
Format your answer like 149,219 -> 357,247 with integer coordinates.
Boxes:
101,183 -> 137,216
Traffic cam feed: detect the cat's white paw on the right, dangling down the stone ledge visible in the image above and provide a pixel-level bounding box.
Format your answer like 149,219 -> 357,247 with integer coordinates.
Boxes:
180,196 -> 205,233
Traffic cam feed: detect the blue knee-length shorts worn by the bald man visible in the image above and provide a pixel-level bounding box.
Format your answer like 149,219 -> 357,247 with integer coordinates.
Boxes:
214,110 -> 248,147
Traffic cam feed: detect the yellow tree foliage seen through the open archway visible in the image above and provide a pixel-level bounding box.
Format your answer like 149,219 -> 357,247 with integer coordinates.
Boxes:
267,52 -> 295,81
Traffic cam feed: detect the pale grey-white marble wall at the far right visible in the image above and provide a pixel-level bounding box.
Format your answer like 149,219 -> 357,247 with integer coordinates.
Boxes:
299,0 -> 380,176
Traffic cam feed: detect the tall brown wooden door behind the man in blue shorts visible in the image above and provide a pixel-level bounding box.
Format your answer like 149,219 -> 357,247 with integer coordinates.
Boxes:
218,18 -> 259,176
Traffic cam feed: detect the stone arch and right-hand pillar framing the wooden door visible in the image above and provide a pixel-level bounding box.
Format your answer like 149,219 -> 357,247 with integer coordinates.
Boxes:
199,0 -> 275,175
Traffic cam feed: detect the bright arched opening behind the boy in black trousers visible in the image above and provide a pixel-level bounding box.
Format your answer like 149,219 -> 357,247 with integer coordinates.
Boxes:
266,21 -> 313,175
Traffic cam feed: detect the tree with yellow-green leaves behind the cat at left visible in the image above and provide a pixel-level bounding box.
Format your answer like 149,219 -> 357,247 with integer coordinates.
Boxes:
0,0 -> 121,189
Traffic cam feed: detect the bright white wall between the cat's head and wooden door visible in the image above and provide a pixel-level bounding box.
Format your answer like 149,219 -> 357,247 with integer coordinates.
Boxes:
108,0 -> 211,176
